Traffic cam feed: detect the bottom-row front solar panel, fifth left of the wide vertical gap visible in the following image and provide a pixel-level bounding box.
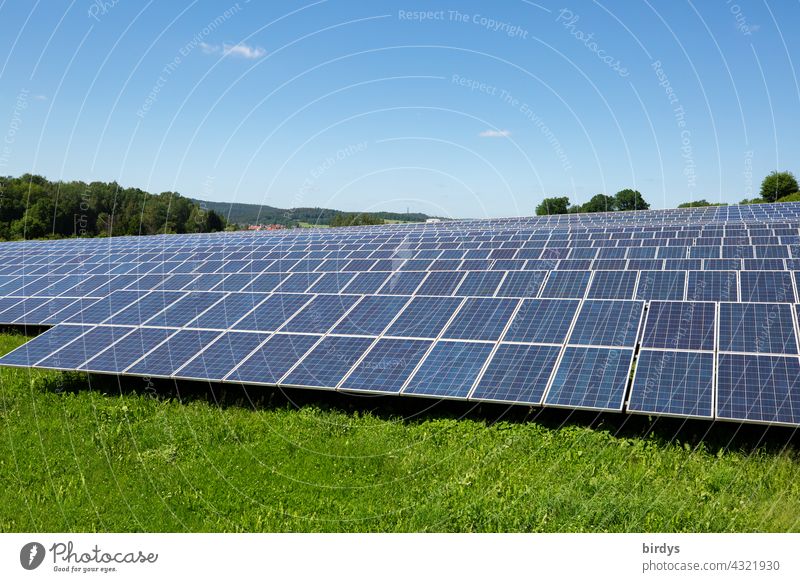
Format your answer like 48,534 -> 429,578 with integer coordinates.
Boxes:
281,336 -> 374,388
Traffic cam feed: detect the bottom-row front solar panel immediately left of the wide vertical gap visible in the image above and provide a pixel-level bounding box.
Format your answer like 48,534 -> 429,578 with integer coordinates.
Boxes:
544,347 -> 633,411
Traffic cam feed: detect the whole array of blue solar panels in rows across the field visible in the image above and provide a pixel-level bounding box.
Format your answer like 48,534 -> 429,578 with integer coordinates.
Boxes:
0,203 -> 800,425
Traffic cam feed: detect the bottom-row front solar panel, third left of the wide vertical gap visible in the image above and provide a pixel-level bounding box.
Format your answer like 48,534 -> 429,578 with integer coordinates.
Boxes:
403,341 -> 492,398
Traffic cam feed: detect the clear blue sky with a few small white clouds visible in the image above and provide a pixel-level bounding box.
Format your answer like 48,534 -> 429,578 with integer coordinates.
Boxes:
0,0 -> 800,217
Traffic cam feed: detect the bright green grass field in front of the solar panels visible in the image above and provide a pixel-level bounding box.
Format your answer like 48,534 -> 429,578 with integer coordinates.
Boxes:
0,335 -> 800,531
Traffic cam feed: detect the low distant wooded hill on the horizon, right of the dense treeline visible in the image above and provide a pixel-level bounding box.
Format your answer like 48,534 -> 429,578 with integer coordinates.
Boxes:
192,199 -> 430,226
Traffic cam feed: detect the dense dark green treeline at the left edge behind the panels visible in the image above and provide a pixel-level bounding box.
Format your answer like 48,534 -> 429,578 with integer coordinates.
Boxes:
0,174 -> 225,240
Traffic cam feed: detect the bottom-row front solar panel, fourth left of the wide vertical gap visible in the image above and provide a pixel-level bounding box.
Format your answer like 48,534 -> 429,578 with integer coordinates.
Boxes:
340,338 -> 432,394
